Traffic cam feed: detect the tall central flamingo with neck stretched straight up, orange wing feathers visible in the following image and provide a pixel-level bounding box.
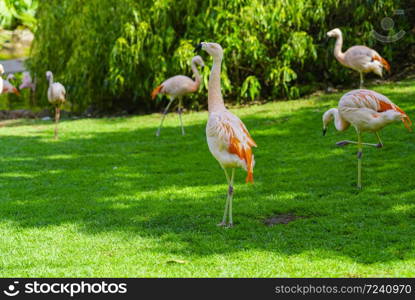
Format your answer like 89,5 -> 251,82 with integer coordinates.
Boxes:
195,42 -> 257,227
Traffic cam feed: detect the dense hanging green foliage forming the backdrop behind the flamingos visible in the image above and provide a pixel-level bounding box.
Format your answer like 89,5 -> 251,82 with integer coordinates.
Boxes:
29,0 -> 415,111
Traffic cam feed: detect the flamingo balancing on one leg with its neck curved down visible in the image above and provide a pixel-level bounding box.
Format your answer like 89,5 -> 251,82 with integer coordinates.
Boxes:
323,89 -> 412,189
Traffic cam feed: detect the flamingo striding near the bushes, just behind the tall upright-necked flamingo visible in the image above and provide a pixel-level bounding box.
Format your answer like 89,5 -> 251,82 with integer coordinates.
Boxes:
151,56 -> 205,136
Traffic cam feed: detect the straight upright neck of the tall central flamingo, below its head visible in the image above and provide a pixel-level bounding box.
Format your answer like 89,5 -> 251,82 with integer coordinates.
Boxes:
208,57 -> 226,112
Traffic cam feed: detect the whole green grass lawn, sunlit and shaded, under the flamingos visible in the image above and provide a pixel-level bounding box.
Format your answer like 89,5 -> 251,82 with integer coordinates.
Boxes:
0,81 -> 415,277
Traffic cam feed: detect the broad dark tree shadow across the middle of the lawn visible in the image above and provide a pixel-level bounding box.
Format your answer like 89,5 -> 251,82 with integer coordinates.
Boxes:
0,89 -> 415,264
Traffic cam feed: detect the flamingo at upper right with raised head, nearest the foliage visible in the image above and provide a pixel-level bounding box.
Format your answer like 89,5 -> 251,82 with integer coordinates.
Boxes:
327,28 -> 390,88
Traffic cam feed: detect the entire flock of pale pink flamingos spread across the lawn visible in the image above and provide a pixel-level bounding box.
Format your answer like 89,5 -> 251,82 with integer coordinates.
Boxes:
0,28 -> 412,227
